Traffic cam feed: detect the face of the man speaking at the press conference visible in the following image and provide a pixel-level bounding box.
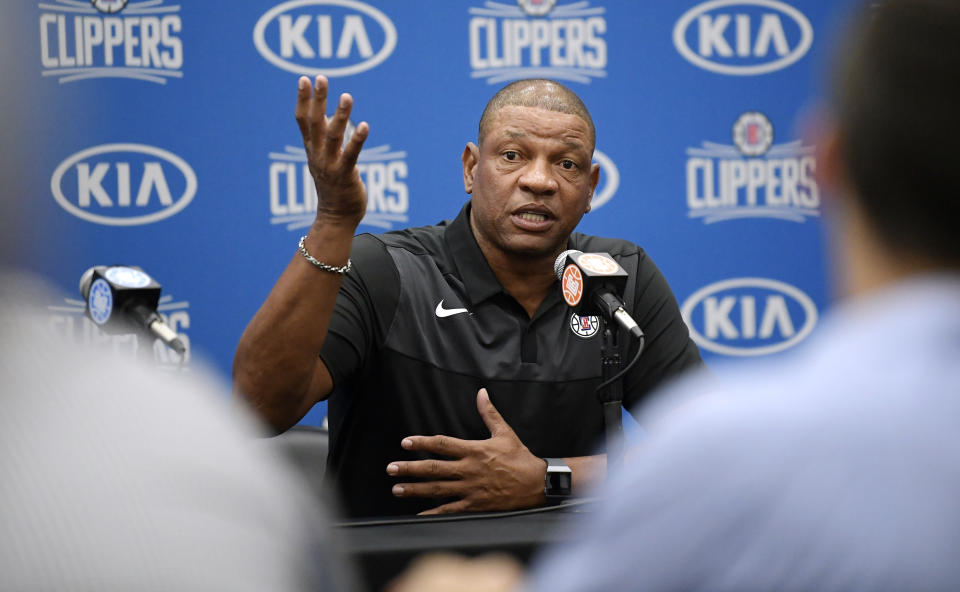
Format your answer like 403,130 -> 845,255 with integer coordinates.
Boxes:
463,106 -> 599,270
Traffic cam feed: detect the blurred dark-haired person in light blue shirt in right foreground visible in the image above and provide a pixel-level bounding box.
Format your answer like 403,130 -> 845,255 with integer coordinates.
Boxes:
396,0 -> 960,592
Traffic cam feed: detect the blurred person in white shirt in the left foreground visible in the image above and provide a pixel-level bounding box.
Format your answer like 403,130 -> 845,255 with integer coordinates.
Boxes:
0,3 -> 349,592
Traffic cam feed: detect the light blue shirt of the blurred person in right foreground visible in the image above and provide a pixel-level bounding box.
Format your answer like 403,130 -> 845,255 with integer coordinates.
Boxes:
529,275 -> 960,592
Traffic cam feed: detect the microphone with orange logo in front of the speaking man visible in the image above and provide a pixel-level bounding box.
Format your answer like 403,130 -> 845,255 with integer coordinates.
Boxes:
553,249 -> 643,339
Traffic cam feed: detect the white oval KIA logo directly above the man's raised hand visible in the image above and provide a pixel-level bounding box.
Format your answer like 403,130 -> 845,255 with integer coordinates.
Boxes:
253,0 -> 397,77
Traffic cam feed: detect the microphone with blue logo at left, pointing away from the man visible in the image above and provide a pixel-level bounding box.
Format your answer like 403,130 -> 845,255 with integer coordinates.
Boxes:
80,265 -> 187,355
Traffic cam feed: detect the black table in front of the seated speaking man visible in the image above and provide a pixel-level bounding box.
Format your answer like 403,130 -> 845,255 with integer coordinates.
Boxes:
334,501 -> 593,591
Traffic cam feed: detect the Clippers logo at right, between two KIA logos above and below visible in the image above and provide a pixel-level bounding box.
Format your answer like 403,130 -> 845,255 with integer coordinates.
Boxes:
686,111 -> 820,224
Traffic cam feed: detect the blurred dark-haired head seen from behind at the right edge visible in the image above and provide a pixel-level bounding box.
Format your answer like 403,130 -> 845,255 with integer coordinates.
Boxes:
826,0 -> 960,268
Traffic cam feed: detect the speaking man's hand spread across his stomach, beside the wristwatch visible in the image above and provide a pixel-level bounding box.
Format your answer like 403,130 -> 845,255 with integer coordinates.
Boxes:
387,389 -> 546,514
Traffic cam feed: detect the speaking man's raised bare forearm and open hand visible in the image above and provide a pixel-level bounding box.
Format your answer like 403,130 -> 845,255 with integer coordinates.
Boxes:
233,76 -> 370,431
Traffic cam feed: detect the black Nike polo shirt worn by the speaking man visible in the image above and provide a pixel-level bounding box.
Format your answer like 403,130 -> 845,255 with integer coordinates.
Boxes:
321,202 -> 701,516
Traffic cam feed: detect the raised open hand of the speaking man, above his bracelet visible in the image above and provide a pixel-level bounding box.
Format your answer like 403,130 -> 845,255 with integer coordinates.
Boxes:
296,76 -> 370,227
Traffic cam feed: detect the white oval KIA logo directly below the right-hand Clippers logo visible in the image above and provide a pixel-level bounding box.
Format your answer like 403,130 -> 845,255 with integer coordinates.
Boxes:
680,277 -> 818,356
